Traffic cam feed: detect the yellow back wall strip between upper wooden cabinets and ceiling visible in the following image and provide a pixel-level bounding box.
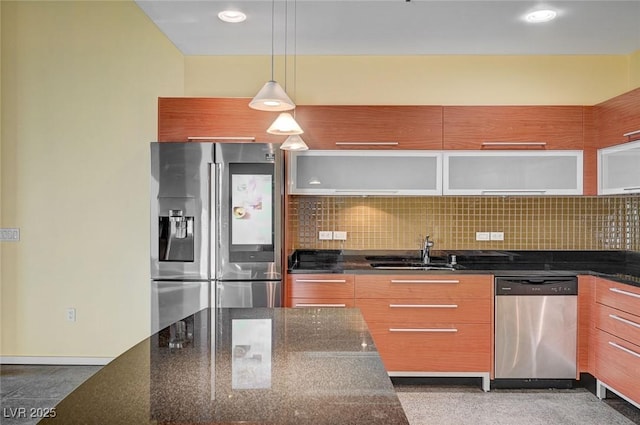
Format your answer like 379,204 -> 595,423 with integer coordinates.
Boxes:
185,56 -> 640,105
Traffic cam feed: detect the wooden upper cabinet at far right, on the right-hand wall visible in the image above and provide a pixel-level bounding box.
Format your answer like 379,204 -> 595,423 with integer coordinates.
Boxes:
594,88 -> 640,148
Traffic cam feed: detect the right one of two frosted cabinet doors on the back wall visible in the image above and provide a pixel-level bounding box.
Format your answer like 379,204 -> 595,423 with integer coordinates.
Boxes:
443,151 -> 582,195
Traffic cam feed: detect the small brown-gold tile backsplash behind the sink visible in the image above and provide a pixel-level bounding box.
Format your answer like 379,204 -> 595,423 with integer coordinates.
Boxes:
288,195 -> 640,251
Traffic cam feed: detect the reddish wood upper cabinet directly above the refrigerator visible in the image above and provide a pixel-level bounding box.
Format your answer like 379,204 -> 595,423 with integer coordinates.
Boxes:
158,97 -> 285,143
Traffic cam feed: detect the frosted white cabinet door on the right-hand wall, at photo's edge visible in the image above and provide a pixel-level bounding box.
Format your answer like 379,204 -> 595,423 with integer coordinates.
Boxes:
598,141 -> 640,195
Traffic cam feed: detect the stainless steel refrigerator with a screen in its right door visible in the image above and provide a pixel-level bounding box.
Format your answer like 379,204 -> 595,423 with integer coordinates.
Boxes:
151,142 -> 284,333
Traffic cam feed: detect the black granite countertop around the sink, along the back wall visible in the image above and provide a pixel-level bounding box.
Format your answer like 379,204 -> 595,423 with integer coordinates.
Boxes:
289,250 -> 640,286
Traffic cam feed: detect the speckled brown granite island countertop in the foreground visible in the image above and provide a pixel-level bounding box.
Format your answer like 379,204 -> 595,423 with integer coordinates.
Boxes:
39,308 -> 408,425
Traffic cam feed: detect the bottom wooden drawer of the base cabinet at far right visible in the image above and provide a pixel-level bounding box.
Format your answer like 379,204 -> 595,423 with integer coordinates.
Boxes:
595,330 -> 640,403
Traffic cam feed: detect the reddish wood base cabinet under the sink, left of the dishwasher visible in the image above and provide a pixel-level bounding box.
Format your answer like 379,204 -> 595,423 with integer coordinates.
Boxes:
355,275 -> 493,390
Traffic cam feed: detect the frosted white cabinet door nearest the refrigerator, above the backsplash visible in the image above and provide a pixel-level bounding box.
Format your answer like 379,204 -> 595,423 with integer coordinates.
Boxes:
289,150 -> 442,196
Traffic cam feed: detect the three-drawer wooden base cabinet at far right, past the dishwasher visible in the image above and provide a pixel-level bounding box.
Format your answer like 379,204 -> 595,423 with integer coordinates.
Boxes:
591,278 -> 640,406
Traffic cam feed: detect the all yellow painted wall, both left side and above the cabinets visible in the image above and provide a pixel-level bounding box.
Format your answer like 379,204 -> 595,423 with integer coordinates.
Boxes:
0,0 -> 640,357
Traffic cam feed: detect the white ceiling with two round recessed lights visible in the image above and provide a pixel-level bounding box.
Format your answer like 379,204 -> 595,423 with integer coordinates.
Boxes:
136,0 -> 640,55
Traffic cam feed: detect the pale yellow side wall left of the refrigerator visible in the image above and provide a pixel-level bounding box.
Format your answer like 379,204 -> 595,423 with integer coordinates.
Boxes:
0,1 -> 184,357
